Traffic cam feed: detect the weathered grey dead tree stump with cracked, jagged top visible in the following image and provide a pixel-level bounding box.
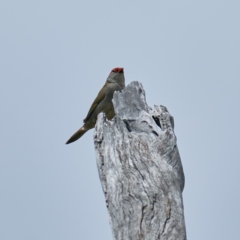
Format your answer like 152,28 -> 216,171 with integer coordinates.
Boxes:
94,82 -> 186,240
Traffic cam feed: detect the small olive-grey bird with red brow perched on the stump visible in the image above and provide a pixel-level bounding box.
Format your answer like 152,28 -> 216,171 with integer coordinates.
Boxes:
66,68 -> 125,144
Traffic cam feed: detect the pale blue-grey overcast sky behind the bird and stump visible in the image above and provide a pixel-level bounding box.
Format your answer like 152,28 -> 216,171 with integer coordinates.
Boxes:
0,0 -> 240,240
